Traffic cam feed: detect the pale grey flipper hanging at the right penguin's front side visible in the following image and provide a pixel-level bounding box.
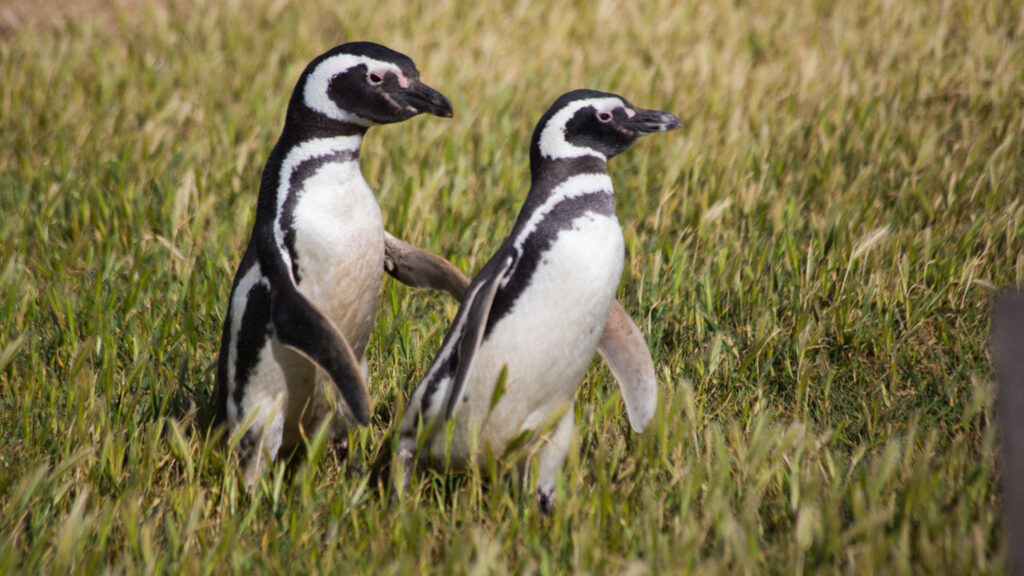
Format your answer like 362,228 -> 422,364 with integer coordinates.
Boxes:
597,300 -> 657,433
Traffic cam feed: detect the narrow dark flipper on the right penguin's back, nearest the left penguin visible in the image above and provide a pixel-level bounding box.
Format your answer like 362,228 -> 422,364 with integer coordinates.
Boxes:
444,255 -> 515,420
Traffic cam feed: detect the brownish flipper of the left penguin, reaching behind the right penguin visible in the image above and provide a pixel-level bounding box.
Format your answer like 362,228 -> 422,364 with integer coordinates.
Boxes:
384,232 -> 469,300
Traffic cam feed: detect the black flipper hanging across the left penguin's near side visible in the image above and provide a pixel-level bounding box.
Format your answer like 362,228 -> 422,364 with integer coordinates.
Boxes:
270,283 -> 370,425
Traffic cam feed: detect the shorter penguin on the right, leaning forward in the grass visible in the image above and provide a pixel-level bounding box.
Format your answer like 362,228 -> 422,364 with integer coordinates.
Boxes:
394,90 -> 680,513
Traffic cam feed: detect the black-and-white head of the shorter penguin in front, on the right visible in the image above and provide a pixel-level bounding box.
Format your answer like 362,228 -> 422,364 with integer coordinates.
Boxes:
530,90 -> 681,160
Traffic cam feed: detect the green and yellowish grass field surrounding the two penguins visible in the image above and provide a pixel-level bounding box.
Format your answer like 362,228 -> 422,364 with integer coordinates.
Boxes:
0,0 -> 1024,574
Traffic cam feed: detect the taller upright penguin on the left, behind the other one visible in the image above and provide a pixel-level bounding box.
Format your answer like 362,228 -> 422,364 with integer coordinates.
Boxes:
214,42 -> 461,490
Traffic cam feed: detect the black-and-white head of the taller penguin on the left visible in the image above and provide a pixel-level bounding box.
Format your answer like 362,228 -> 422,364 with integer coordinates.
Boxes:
288,42 -> 452,128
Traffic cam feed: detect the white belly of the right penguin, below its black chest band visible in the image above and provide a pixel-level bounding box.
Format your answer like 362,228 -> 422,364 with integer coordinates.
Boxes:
434,214 -> 625,459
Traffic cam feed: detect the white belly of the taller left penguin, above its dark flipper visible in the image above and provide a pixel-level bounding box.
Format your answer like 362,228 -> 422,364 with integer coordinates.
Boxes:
294,162 -> 384,361
